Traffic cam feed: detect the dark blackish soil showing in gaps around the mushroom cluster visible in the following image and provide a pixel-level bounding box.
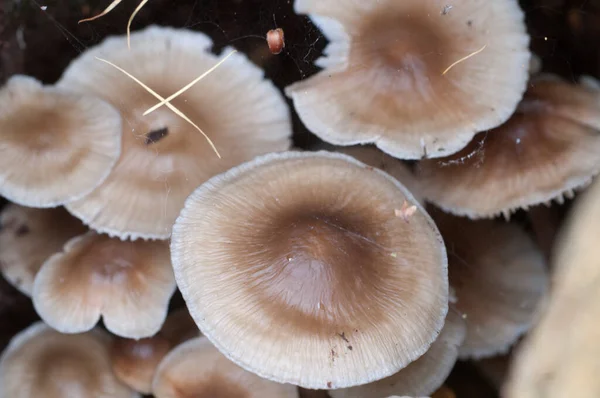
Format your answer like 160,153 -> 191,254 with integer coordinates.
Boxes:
0,0 -> 600,398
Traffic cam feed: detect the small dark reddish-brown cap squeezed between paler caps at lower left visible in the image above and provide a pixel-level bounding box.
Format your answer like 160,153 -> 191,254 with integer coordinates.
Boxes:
111,309 -> 200,394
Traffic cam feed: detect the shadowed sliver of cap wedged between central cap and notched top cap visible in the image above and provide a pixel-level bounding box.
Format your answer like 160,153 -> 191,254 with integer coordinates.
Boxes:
337,146 -> 425,205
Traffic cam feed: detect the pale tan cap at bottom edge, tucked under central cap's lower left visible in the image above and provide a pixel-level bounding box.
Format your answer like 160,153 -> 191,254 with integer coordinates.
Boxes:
153,337 -> 298,398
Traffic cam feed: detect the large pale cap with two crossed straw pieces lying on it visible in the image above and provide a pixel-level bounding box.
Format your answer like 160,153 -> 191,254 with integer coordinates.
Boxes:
58,27 -> 291,239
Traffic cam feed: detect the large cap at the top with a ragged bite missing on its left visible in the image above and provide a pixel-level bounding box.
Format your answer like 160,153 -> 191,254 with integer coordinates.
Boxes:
286,0 -> 530,159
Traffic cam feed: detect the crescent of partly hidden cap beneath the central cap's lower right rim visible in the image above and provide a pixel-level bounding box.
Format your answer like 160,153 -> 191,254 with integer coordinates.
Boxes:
329,310 -> 466,398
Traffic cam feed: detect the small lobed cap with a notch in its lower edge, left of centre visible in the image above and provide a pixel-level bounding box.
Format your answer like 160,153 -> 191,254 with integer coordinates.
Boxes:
33,231 -> 176,338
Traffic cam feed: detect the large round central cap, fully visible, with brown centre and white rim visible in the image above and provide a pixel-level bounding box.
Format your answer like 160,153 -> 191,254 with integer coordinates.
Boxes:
171,152 -> 448,389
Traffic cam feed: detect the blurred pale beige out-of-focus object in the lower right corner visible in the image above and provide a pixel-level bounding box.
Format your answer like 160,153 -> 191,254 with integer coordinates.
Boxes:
503,181 -> 600,398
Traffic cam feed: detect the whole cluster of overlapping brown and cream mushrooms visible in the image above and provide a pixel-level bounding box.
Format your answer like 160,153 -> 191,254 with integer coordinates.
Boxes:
0,0 -> 600,398
